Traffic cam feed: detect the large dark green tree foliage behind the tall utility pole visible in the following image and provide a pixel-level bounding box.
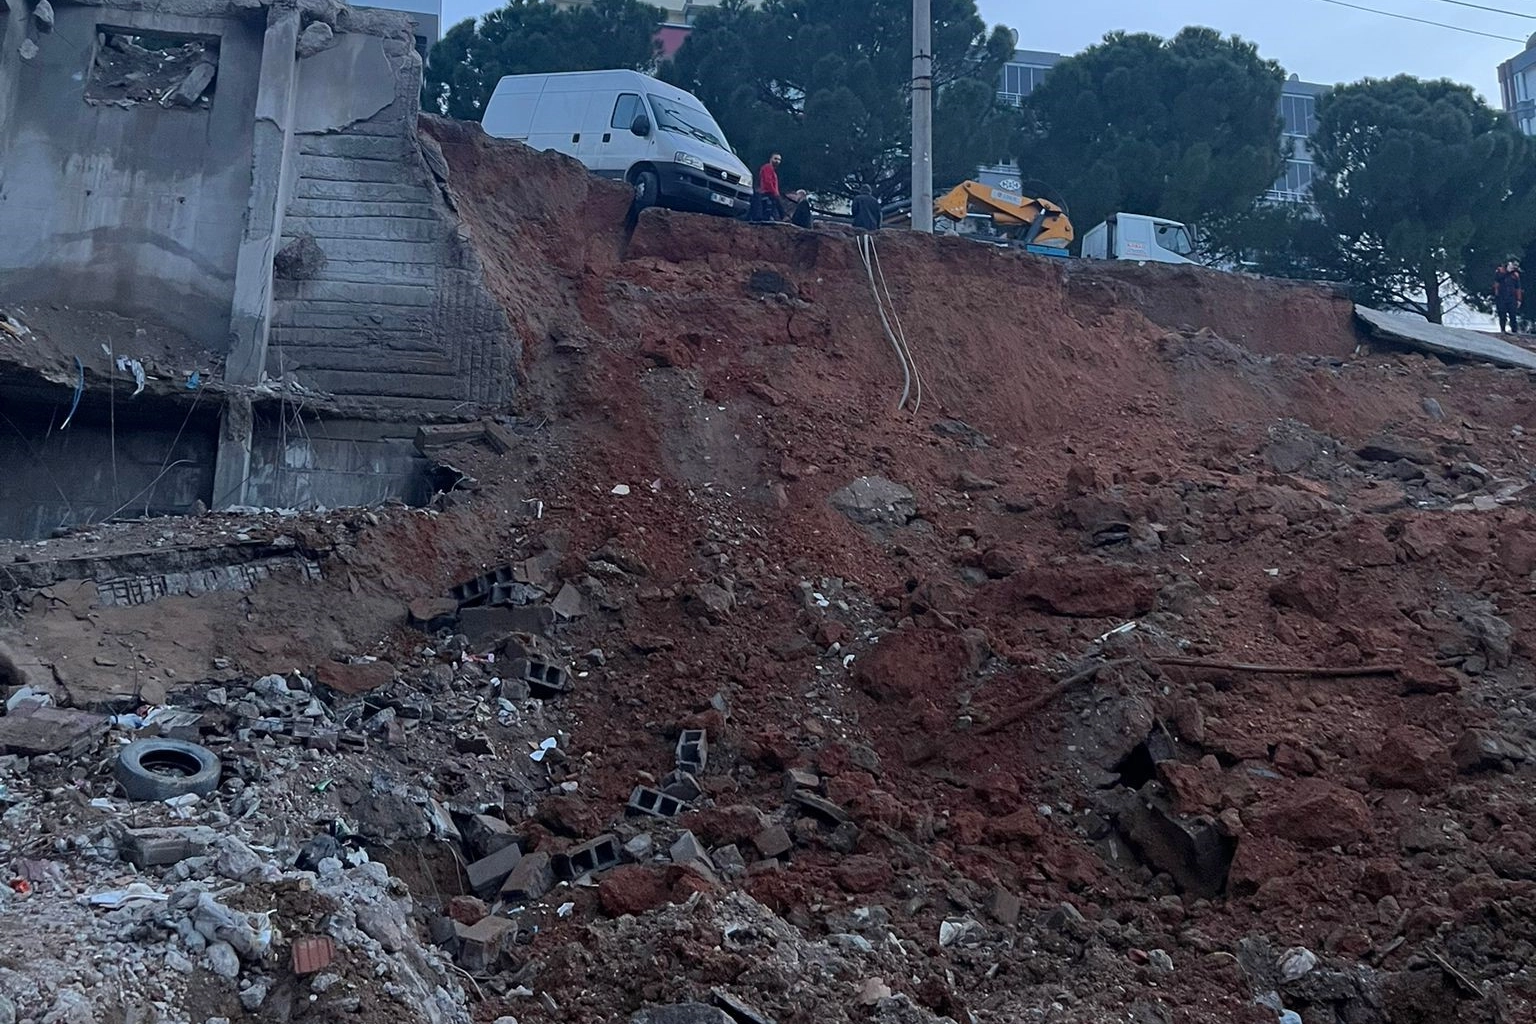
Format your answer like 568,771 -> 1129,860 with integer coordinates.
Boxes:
662,0 -> 1014,201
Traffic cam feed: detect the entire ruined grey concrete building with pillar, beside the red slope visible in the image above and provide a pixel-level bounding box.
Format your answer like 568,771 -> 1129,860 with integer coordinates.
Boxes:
0,0 -> 519,537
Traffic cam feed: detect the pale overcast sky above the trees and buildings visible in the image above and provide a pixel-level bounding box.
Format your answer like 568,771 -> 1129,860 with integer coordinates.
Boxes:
442,0 -> 1536,106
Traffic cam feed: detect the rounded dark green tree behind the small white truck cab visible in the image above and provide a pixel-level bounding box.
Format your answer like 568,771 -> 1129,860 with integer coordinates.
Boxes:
1015,28 -> 1286,236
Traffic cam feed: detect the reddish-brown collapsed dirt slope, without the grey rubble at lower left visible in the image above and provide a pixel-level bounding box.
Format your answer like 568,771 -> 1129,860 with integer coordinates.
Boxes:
9,121 -> 1536,1024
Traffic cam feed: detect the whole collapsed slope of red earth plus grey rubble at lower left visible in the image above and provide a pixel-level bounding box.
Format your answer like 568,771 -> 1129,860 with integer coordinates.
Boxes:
0,123 -> 1536,1024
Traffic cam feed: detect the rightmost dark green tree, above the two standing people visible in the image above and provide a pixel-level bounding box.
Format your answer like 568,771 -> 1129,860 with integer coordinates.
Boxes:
1312,75 -> 1536,324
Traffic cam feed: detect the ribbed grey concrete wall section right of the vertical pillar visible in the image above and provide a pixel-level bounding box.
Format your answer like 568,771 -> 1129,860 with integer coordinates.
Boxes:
267,34 -> 518,413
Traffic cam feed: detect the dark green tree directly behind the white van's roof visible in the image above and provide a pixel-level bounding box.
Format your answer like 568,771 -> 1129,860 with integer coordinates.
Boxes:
421,0 -> 664,120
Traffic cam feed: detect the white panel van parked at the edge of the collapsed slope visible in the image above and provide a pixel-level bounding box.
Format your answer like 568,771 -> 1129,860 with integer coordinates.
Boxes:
481,71 -> 753,215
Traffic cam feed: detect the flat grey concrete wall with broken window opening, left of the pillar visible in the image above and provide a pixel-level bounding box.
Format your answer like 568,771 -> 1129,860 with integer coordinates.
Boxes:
0,5 -> 266,352
